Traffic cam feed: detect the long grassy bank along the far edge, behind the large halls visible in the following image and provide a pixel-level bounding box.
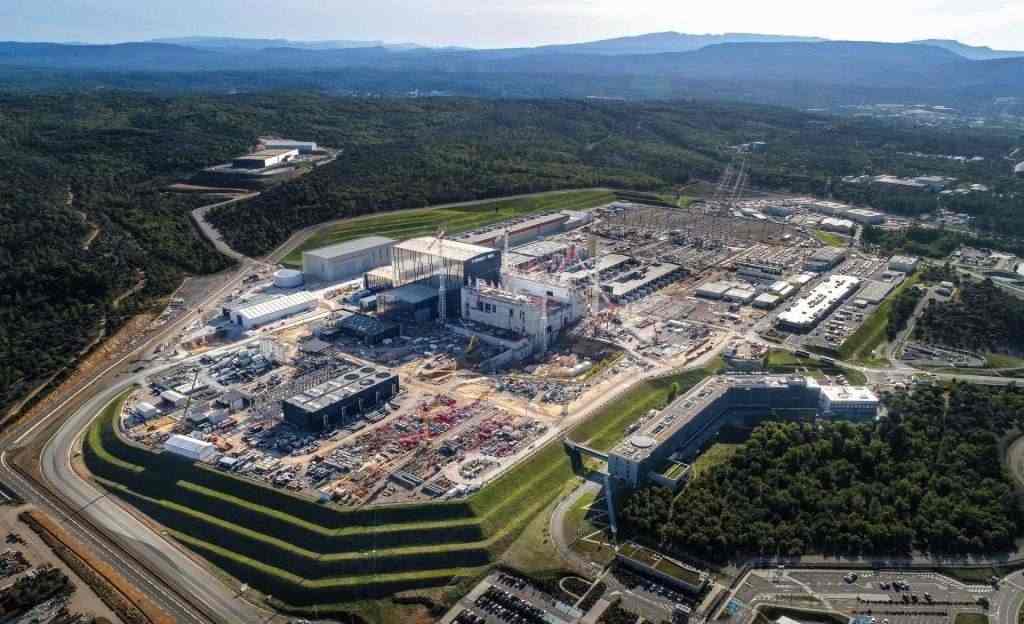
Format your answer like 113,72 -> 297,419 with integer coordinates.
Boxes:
283,191 -> 615,266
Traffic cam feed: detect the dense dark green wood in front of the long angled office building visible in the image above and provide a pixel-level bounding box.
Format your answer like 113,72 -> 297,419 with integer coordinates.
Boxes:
624,384 -> 1024,561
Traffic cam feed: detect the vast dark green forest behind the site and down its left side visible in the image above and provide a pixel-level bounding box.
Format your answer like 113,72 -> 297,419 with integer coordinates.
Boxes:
0,91 -> 1024,407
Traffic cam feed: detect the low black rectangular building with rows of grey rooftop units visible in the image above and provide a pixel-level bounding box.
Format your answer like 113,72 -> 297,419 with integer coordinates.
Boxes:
282,364 -> 398,431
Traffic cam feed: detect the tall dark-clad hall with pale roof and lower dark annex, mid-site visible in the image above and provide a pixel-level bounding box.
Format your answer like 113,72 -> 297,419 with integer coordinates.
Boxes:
377,237 -> 502,322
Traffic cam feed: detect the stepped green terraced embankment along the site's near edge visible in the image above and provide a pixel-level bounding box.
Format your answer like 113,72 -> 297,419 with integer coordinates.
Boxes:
83,372 -> 716,607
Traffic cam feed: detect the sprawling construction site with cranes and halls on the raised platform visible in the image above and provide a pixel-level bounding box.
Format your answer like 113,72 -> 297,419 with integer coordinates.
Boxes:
122,155 -> 913,505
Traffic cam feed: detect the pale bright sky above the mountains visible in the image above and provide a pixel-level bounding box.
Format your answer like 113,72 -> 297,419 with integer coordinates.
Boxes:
0,0 -> 1024,49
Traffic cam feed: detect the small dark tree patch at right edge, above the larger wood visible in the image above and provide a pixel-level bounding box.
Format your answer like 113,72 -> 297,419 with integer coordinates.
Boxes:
913,280 -> 1024,355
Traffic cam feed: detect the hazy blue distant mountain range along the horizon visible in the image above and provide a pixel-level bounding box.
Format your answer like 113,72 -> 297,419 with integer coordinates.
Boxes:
0,33 -> 1024,106
